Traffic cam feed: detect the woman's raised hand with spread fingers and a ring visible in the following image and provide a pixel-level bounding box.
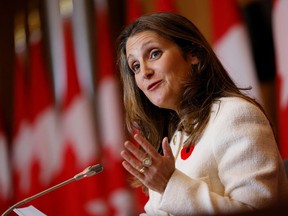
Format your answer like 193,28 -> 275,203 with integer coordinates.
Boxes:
121,134 -> 175,193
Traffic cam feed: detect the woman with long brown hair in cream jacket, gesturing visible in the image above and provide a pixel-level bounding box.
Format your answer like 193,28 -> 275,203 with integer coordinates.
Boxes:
118,12 -> 287,216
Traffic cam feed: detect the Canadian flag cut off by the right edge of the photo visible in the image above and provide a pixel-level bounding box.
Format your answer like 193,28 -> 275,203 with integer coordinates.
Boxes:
272,0 -> 288,159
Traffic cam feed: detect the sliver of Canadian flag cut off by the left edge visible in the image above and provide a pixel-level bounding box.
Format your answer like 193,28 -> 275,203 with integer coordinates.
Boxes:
0,113 -> 12,212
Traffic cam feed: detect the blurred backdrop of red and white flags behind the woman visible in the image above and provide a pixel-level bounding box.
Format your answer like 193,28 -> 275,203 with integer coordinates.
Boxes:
0,0 -> 288,216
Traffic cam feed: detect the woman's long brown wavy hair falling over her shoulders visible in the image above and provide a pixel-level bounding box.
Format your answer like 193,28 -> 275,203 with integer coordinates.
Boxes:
117,12 -> 263,187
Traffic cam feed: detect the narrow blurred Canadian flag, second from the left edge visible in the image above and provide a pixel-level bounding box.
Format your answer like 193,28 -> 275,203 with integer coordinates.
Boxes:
11,23 -> 33,202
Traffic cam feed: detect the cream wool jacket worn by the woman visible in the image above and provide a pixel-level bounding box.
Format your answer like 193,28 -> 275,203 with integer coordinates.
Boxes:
141,97 -> 288,216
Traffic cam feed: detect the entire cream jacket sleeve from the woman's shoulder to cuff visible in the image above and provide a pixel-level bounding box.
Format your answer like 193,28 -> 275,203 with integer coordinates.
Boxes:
160,98 -> 287,215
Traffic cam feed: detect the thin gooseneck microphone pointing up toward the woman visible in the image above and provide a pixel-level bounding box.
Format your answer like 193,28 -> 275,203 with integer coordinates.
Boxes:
1,164 -> 103,216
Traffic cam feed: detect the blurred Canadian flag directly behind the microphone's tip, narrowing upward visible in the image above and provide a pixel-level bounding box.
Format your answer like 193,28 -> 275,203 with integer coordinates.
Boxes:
57,13 -> 107,215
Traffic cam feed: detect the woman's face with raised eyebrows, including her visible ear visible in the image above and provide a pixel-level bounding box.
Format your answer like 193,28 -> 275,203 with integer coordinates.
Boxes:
126,31 -> 198,112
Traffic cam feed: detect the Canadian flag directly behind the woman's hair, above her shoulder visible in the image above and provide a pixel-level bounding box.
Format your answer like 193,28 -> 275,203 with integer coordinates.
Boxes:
211,0 -> 261,102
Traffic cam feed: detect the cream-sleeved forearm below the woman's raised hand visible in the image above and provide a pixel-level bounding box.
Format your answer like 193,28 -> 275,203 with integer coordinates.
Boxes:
160,170 -> 253,215
